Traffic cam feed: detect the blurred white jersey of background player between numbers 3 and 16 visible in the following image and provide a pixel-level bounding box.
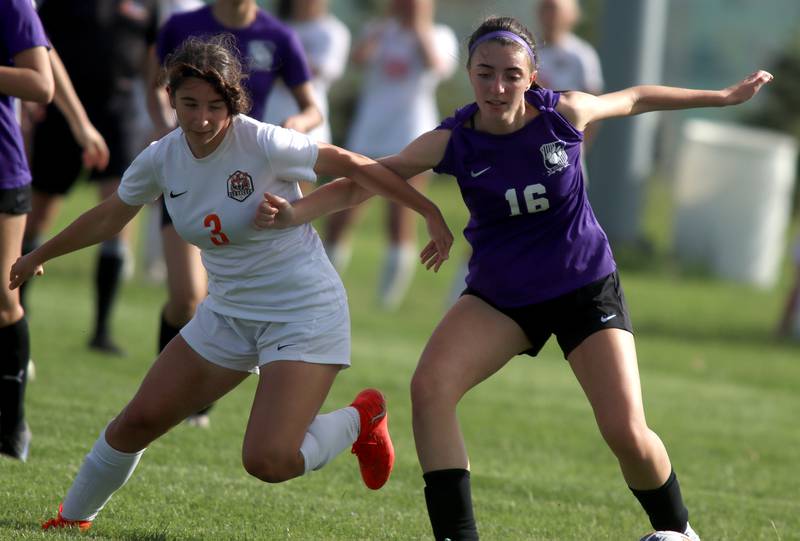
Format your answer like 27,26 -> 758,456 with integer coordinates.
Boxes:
345,21 -> 458,158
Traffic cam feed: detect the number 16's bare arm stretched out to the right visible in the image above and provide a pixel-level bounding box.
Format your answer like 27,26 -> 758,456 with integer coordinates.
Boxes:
557,70 -> 772,130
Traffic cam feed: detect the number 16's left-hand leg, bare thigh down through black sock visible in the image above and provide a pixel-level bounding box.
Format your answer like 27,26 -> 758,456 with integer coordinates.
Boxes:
411,295 -> 531,539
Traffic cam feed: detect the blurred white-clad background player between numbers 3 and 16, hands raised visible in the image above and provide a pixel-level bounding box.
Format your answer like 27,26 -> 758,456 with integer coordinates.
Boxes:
324,0 -> 458,309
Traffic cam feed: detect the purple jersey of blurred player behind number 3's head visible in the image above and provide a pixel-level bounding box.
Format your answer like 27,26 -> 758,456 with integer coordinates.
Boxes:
157,6 -> 311,120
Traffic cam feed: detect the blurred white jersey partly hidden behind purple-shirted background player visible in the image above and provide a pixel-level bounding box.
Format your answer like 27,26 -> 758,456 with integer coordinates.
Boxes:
264,15 -> 350,143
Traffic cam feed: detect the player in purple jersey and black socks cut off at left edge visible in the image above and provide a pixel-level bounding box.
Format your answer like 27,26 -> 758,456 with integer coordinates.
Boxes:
0,0 -> 54,461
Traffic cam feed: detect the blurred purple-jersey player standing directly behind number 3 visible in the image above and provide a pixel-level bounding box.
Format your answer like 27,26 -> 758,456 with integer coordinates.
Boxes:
148,0 -> 322,426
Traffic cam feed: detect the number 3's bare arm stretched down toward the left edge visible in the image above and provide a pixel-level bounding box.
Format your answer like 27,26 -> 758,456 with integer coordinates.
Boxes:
9,193 -> 142,289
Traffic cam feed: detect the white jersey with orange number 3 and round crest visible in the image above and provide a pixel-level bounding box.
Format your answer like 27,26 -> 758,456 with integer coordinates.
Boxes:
118,115 -> 347,321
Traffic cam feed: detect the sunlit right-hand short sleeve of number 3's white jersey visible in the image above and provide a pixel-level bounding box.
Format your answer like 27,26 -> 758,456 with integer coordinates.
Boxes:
258,124 -> 319,182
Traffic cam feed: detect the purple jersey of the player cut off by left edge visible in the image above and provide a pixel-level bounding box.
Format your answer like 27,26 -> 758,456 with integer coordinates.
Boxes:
0,0 -> 50,189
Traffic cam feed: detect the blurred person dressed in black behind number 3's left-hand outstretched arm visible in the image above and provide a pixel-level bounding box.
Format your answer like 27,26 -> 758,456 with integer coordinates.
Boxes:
23,0 -> 158,354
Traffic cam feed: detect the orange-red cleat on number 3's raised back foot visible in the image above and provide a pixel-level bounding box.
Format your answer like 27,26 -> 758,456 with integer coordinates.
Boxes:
350,389 -> 394,490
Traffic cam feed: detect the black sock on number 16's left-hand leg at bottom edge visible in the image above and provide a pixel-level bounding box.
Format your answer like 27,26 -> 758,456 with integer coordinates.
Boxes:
422,469 -> 478,541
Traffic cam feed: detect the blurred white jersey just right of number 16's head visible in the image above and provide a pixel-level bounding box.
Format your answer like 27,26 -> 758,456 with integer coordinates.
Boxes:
536,34 -> 603,94
